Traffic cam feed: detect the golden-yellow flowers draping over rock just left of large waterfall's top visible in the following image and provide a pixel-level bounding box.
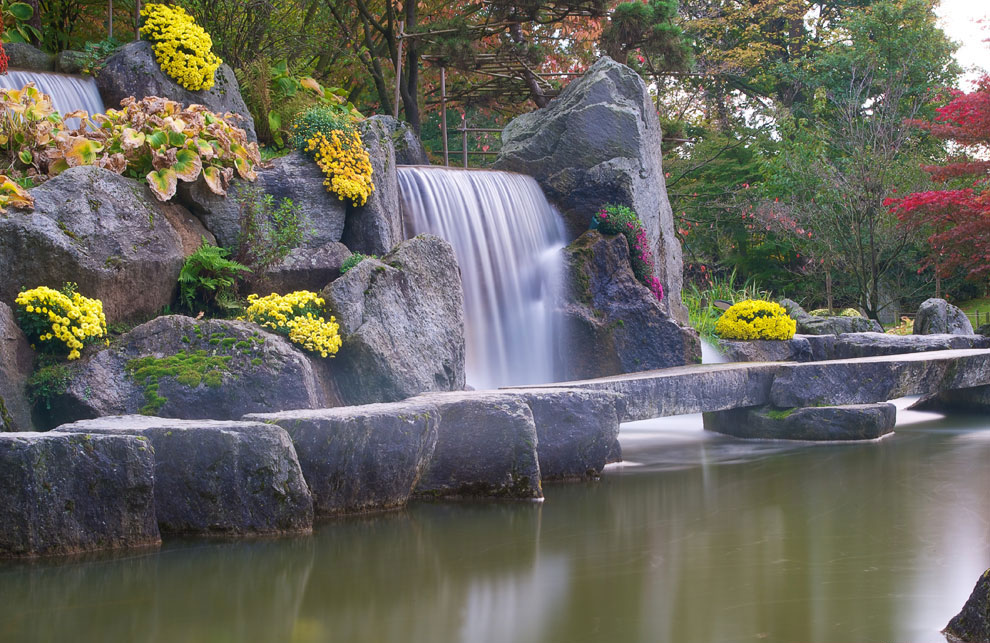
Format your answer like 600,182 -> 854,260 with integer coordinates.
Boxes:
306,130 -> 375,205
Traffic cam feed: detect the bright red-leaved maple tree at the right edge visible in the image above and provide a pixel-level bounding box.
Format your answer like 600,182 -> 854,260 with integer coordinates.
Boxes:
885,76 -> 990,280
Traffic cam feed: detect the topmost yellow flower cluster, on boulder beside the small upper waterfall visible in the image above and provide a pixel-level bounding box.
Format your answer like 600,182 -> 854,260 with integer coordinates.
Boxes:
141,4 -> 223,91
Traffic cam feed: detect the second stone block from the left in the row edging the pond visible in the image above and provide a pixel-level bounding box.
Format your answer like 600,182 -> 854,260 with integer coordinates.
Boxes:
55,415 -> 313,535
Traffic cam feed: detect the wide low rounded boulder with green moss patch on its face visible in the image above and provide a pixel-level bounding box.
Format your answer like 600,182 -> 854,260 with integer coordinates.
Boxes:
48,315 -> 336,426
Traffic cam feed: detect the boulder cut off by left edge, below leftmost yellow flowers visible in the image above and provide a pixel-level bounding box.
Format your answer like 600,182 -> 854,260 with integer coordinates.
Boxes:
0,302 -> 34,431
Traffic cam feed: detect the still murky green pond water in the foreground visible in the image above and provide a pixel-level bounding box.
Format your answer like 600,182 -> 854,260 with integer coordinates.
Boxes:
0,412 -> 990,643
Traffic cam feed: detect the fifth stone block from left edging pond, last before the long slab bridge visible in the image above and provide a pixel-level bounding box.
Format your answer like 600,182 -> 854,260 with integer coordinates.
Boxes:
505,388 -> 625,481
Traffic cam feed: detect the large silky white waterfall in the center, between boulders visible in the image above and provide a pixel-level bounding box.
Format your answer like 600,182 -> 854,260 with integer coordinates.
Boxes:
398,166 -> 564,389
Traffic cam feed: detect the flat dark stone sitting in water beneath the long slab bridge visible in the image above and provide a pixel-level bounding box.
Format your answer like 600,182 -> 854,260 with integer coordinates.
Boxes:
704,403 -> 897,442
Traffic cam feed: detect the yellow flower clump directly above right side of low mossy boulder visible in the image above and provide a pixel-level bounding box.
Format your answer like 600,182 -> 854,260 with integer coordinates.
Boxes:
240,290 -> 341,357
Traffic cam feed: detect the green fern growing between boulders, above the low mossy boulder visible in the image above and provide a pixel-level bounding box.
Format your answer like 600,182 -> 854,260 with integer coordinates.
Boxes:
179,239 -> 251,313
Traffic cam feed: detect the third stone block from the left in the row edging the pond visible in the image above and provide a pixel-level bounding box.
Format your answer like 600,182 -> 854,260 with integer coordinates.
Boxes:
244,401 -> 440,515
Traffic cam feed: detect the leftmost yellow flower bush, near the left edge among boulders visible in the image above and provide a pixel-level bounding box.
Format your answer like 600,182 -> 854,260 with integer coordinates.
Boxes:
14,286 -> 107,359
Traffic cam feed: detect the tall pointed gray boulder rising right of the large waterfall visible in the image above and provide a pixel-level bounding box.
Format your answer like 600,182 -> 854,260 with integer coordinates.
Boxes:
494,57 -> 687,323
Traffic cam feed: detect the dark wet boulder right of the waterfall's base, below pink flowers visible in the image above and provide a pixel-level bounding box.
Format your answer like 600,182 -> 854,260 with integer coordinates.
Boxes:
559,230 -> 701,380
